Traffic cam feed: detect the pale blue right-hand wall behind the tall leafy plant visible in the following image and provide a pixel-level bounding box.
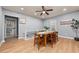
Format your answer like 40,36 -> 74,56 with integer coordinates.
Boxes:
44,11 -> 79,38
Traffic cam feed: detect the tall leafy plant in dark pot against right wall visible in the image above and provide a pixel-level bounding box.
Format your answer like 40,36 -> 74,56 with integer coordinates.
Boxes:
71,19 -> 79,41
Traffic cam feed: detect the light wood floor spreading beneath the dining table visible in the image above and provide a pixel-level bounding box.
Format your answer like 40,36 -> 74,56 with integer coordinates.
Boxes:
0,38 -> 79,53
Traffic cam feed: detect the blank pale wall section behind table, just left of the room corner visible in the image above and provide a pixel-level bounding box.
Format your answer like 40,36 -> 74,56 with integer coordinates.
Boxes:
26,17 -> 43,32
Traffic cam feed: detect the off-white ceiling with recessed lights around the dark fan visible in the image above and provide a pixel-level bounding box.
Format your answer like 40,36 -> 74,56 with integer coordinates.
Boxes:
3,6 -> 79,19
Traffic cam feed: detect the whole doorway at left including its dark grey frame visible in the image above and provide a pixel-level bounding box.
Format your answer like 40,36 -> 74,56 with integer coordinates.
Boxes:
5,15 -> 18,40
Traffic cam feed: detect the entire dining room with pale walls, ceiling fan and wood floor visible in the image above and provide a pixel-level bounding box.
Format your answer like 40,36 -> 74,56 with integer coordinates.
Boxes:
0,6 -> 79,53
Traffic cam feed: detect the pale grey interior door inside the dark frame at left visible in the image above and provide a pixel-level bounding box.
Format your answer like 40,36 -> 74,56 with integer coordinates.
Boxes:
5,17 -> 17,38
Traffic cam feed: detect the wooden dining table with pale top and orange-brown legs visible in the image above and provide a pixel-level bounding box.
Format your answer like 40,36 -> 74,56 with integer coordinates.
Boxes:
36,31 -> 58,49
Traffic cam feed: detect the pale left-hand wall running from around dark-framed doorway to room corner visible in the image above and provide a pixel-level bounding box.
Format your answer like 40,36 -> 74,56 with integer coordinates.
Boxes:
3,10 -> 43,38
